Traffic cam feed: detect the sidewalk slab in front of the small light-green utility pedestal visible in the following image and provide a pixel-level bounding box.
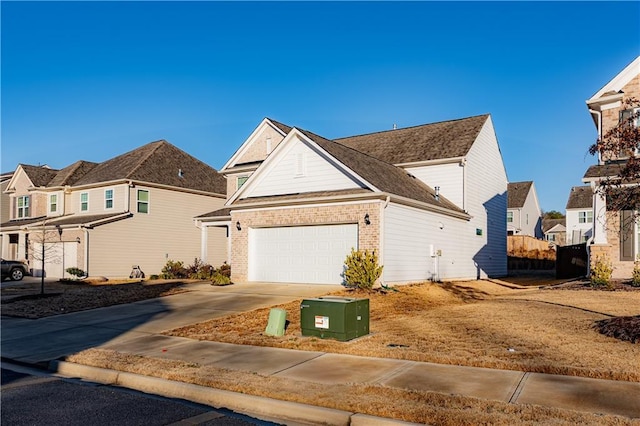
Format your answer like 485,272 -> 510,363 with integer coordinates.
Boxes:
207,345 -> 323,375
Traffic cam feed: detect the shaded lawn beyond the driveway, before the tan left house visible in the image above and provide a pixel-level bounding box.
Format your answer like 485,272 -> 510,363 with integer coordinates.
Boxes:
0,280 -> 188,319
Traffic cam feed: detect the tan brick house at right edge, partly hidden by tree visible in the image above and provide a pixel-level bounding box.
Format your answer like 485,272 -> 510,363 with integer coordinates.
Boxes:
582,56 -> 640,278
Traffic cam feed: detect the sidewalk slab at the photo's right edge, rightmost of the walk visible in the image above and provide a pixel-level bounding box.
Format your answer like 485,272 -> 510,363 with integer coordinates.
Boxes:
515,373 -> 640,418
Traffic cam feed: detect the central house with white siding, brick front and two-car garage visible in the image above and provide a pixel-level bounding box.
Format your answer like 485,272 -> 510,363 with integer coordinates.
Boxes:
196,115 -> 507,284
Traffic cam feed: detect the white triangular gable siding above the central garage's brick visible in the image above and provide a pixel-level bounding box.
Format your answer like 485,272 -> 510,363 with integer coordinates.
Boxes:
243,137 -> 360,197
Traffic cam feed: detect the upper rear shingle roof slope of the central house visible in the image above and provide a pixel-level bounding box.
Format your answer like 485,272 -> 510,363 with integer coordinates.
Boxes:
335,114 -> 489,164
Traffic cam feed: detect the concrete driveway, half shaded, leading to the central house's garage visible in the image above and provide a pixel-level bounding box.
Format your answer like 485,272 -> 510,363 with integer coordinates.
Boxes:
0,283 -> 342,366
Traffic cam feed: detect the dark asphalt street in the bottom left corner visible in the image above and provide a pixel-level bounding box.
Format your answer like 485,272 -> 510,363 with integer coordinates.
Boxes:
0,363 -> 275,426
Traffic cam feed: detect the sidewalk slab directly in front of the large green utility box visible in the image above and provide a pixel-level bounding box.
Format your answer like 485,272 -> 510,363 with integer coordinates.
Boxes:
275,354 -> 410,384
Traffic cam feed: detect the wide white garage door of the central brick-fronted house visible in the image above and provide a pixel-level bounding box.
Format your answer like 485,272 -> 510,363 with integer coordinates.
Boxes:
249,224 -> 358,284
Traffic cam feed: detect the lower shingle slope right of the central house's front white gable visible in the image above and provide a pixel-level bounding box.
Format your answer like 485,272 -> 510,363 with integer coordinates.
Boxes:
299,129 -> 462,212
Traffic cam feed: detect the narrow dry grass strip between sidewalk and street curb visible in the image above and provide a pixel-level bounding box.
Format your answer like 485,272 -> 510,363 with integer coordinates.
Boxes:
68,349 -> 640,426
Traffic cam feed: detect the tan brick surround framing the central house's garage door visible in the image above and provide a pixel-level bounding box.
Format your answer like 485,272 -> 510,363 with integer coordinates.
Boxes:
231,201 -> 381,282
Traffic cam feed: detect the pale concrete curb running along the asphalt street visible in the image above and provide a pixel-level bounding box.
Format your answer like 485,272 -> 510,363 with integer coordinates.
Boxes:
49,360 -> 415,426
